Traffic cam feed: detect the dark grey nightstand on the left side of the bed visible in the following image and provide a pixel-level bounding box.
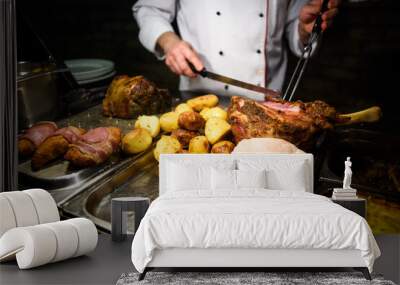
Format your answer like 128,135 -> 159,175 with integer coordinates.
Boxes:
111,197 -> 150,241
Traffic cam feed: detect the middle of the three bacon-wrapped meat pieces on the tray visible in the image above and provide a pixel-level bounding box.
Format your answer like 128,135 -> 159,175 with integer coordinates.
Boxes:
31,126 -> 85,170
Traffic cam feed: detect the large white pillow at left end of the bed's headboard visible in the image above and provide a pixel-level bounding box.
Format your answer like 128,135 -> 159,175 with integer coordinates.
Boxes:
167,163 -> 211,191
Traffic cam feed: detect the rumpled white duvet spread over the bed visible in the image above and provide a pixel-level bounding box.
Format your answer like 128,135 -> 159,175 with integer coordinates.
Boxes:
132,189 -> 380,272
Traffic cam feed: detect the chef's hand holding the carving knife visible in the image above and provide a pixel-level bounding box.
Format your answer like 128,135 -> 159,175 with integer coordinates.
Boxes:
157,32 -> 204,78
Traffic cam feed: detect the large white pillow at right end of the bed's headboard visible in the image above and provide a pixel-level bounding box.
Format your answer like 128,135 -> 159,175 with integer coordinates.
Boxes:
238,159 -> 312,192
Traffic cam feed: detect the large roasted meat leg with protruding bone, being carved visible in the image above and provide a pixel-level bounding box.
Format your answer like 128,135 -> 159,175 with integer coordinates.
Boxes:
228,96 -> 381,149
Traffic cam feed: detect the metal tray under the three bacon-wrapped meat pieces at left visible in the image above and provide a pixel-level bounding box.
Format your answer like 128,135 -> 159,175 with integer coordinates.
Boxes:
18,104 -> 141,202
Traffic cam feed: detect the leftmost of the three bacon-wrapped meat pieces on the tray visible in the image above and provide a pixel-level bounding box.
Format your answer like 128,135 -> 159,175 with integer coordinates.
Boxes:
18,121 -> 58,157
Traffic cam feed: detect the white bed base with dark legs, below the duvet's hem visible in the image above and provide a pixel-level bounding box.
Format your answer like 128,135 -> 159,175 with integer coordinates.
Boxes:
139,248 -> 371,281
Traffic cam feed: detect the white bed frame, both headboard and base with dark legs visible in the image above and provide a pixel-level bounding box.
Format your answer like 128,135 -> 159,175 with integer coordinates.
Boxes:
139,154 -> 371,280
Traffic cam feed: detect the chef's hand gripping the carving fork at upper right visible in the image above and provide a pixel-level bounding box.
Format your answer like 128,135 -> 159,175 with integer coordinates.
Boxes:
299,0 -> 341,44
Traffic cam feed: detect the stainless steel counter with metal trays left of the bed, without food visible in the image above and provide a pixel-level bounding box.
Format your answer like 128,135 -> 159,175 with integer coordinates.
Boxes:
18,104 -> 158,229
